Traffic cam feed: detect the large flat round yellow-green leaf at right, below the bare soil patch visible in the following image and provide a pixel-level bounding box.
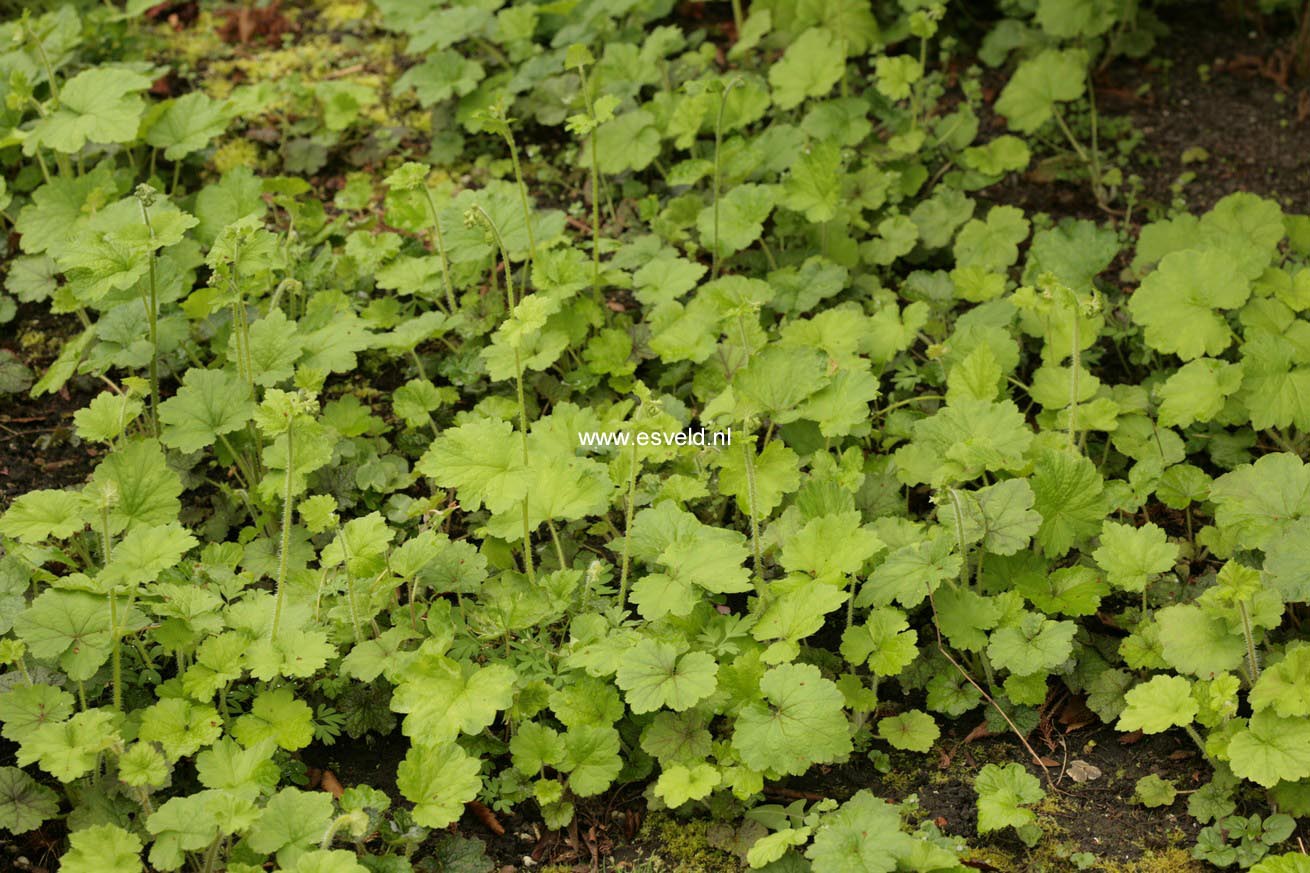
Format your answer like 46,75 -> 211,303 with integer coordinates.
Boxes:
1128,250 -> 1251,360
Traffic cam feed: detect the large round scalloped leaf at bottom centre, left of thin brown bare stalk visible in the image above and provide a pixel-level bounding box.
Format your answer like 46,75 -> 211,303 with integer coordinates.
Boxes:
732,663 -> 852,775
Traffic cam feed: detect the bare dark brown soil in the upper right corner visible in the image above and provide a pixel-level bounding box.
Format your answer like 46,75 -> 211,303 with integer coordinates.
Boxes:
983,4 -> 1310,220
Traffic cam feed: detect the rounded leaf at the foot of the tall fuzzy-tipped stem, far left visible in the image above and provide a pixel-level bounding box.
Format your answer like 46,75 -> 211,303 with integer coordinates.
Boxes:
160,367 -> 254,452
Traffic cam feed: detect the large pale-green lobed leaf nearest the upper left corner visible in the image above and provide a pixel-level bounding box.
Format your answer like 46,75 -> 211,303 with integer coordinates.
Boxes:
22,67 -> 151,155
